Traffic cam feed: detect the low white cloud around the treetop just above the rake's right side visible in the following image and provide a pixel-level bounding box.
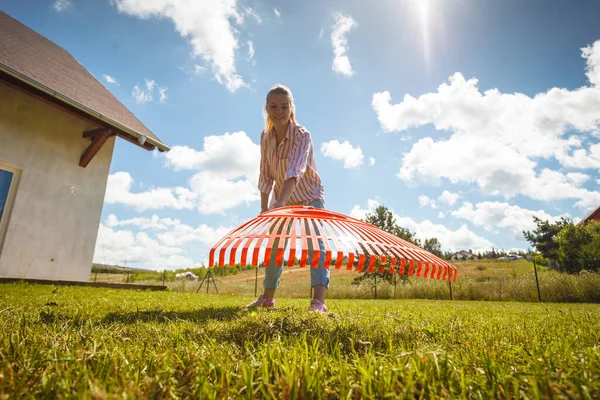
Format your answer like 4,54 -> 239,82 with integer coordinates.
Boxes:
349,199 -> 494,251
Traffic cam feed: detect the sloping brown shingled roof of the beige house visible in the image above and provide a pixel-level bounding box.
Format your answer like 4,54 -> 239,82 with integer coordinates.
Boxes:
0,11 -> 169,151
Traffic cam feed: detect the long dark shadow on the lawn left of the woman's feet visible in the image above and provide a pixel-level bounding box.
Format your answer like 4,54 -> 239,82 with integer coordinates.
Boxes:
100,306 -> 246,324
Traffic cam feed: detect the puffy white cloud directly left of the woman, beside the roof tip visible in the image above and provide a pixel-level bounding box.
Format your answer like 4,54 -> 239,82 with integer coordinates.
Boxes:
164,132 -> 260,214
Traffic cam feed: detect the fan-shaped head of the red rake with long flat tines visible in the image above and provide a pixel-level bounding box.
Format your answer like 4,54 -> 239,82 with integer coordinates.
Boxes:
209,206 -> 457,281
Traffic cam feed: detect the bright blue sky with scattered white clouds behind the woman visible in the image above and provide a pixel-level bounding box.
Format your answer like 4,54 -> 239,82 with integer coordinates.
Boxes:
0,0 -> 600,269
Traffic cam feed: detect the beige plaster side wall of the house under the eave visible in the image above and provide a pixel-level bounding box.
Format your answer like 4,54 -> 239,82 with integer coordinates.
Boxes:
0,82 -> 114,281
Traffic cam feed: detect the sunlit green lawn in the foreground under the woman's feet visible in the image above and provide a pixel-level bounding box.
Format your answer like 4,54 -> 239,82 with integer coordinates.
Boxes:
0,284 -> 600,399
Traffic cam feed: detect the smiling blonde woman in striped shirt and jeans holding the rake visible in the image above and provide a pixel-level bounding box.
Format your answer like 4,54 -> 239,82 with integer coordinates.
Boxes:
248,85 -> 329,313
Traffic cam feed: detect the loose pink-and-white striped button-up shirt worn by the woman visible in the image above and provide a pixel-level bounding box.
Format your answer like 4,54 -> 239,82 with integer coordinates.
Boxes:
258,121 -> 325,208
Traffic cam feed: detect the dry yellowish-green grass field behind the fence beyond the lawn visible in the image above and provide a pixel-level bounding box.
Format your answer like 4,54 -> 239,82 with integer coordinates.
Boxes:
102,260 -> 600,303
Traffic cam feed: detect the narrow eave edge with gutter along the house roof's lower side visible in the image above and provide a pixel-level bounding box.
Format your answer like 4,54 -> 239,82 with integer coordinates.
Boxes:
0,63 -> 171,151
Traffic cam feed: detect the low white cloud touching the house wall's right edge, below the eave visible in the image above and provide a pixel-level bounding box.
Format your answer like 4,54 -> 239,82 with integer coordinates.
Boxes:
104,172 -> 197,211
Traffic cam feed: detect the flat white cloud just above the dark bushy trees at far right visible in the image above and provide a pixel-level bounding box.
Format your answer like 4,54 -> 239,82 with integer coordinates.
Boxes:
452,201 -> 568,240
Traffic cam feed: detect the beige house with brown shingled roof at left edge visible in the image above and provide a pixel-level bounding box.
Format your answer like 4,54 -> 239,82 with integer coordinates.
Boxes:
0,11 -> 169,281
